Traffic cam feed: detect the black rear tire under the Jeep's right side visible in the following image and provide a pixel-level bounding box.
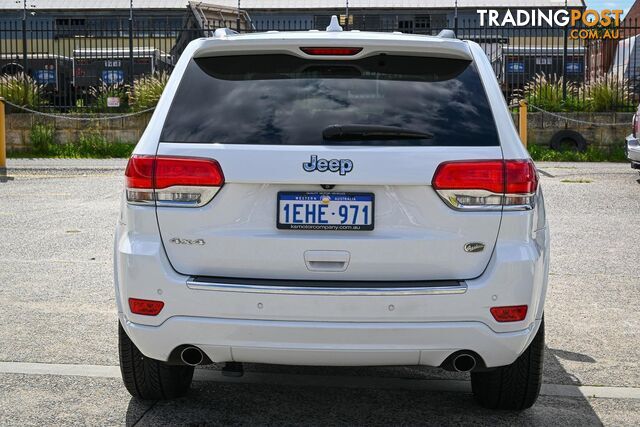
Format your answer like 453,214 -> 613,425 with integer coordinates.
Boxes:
471,318 -> 544,411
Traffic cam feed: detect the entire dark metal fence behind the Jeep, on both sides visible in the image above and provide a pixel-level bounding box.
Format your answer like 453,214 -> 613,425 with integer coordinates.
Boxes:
0,16 -> 640,112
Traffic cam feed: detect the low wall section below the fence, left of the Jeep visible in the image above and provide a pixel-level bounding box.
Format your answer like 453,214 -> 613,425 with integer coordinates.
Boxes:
6,113 -> 151,151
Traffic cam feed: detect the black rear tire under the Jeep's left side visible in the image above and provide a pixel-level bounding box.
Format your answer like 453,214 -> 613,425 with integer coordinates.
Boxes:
118,322 -> 193,400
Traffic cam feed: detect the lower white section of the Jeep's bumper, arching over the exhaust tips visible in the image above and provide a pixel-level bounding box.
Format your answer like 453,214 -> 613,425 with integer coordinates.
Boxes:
120,314 -> 540,367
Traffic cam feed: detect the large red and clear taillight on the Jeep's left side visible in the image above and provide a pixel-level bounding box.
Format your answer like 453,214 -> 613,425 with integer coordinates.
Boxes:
125,155 -> 224,207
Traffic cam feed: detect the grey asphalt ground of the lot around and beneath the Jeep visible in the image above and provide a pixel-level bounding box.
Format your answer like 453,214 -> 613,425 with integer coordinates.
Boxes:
0,159 -> 640,426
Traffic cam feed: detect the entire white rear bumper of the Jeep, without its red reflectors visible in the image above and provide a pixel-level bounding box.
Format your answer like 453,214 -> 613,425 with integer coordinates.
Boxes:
114,202 -> 549,367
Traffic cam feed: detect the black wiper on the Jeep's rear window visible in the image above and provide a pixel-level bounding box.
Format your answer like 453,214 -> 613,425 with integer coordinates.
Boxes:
322,125 -> 433,141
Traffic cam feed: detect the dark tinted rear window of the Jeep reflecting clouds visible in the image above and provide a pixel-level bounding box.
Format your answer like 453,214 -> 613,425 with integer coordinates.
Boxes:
161,54 -> 499,146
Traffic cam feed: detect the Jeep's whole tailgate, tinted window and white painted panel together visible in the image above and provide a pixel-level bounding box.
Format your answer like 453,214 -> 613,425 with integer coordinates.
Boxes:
152,44 -> 502,281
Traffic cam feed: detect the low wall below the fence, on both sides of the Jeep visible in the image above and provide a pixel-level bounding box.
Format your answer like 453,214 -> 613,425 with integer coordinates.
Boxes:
6,113 -> 633,150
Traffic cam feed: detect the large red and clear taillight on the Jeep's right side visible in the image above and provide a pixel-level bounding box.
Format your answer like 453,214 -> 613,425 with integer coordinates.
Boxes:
431,160 -> 538,210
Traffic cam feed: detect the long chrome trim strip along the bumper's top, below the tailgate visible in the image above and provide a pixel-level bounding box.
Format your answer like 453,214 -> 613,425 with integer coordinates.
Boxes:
187,279 -> 467,296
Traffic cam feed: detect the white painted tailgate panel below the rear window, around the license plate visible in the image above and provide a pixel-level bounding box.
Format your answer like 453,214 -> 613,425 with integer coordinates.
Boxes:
157,143 -> 501,280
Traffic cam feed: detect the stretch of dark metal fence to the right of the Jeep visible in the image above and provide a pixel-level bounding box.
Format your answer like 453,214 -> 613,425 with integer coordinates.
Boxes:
457,22 -> 640,112
